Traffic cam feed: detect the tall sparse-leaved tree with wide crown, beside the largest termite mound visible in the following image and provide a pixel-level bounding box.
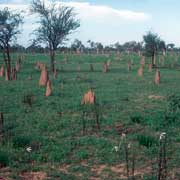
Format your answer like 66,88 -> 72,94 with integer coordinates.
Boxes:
31,0 -> 80,72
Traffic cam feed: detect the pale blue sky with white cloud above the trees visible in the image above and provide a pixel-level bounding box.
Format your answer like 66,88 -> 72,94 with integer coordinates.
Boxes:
0,0 -> 180,47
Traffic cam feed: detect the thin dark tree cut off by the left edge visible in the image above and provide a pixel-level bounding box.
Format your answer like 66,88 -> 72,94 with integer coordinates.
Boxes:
0,8 -> 23,79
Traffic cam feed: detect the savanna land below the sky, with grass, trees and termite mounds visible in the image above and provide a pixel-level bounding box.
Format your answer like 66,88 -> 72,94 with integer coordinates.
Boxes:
0,0 -> 180,180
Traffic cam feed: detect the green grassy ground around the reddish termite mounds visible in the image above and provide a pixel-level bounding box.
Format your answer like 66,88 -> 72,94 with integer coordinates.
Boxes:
0,54 -> 180,180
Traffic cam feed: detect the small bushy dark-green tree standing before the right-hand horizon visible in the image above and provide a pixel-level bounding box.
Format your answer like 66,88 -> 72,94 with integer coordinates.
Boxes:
143,32 -> 161,67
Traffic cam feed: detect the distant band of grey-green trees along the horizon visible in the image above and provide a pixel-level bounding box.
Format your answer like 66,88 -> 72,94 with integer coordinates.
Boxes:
0,39 -> 180,54
